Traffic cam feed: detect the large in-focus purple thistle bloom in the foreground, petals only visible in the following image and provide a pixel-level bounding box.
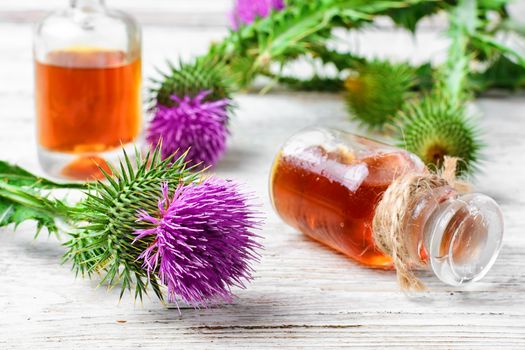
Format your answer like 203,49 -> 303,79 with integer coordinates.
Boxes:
135,178 -> 261,307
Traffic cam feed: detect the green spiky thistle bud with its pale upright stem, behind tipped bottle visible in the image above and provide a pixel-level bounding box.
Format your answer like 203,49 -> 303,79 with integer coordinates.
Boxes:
398,0 -> 483,175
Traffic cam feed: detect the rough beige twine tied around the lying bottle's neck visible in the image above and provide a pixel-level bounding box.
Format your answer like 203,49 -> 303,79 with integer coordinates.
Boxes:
372,157 -> 470,290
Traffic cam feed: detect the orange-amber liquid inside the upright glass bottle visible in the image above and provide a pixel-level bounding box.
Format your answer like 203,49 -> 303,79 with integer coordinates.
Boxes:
35,49 -> 142,179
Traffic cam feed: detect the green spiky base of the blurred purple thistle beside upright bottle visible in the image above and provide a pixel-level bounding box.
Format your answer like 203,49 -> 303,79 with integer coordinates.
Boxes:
150,57 -> 233,107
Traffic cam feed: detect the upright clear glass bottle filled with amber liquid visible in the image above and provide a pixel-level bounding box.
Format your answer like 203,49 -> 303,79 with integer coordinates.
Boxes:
33,0 -> 142,180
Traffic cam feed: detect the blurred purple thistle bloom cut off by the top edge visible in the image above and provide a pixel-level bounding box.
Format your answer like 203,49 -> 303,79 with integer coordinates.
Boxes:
231,0 -> 285,30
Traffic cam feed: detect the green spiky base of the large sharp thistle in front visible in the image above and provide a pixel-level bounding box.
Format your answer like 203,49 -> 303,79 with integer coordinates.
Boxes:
65,146 -> 200,300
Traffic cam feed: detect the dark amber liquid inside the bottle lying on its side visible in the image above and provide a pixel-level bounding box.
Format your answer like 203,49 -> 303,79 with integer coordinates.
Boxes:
271,147 -> 422,268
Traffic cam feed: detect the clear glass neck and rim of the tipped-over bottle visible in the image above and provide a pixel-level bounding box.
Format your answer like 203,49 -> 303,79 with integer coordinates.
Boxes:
405,186 -> 503,285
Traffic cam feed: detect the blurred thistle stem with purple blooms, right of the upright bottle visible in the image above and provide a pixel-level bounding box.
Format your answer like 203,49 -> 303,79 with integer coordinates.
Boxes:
147,0 -> 432,167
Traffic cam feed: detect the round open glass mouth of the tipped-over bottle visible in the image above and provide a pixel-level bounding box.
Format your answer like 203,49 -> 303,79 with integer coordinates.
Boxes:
425,193 -> 503,286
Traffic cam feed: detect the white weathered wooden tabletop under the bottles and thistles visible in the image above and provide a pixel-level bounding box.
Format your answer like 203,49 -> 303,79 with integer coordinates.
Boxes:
0,0 -> 525,350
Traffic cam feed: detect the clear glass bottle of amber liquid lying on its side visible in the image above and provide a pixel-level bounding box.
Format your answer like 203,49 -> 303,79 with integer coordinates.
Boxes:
270,128 -> 503,285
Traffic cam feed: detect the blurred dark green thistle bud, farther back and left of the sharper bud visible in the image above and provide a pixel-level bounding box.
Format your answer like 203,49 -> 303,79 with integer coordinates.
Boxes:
345,60 -> 416,129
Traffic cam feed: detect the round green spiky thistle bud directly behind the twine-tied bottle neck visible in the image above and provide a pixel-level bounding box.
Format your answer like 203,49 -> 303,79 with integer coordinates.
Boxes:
397,94 -> 483,175
